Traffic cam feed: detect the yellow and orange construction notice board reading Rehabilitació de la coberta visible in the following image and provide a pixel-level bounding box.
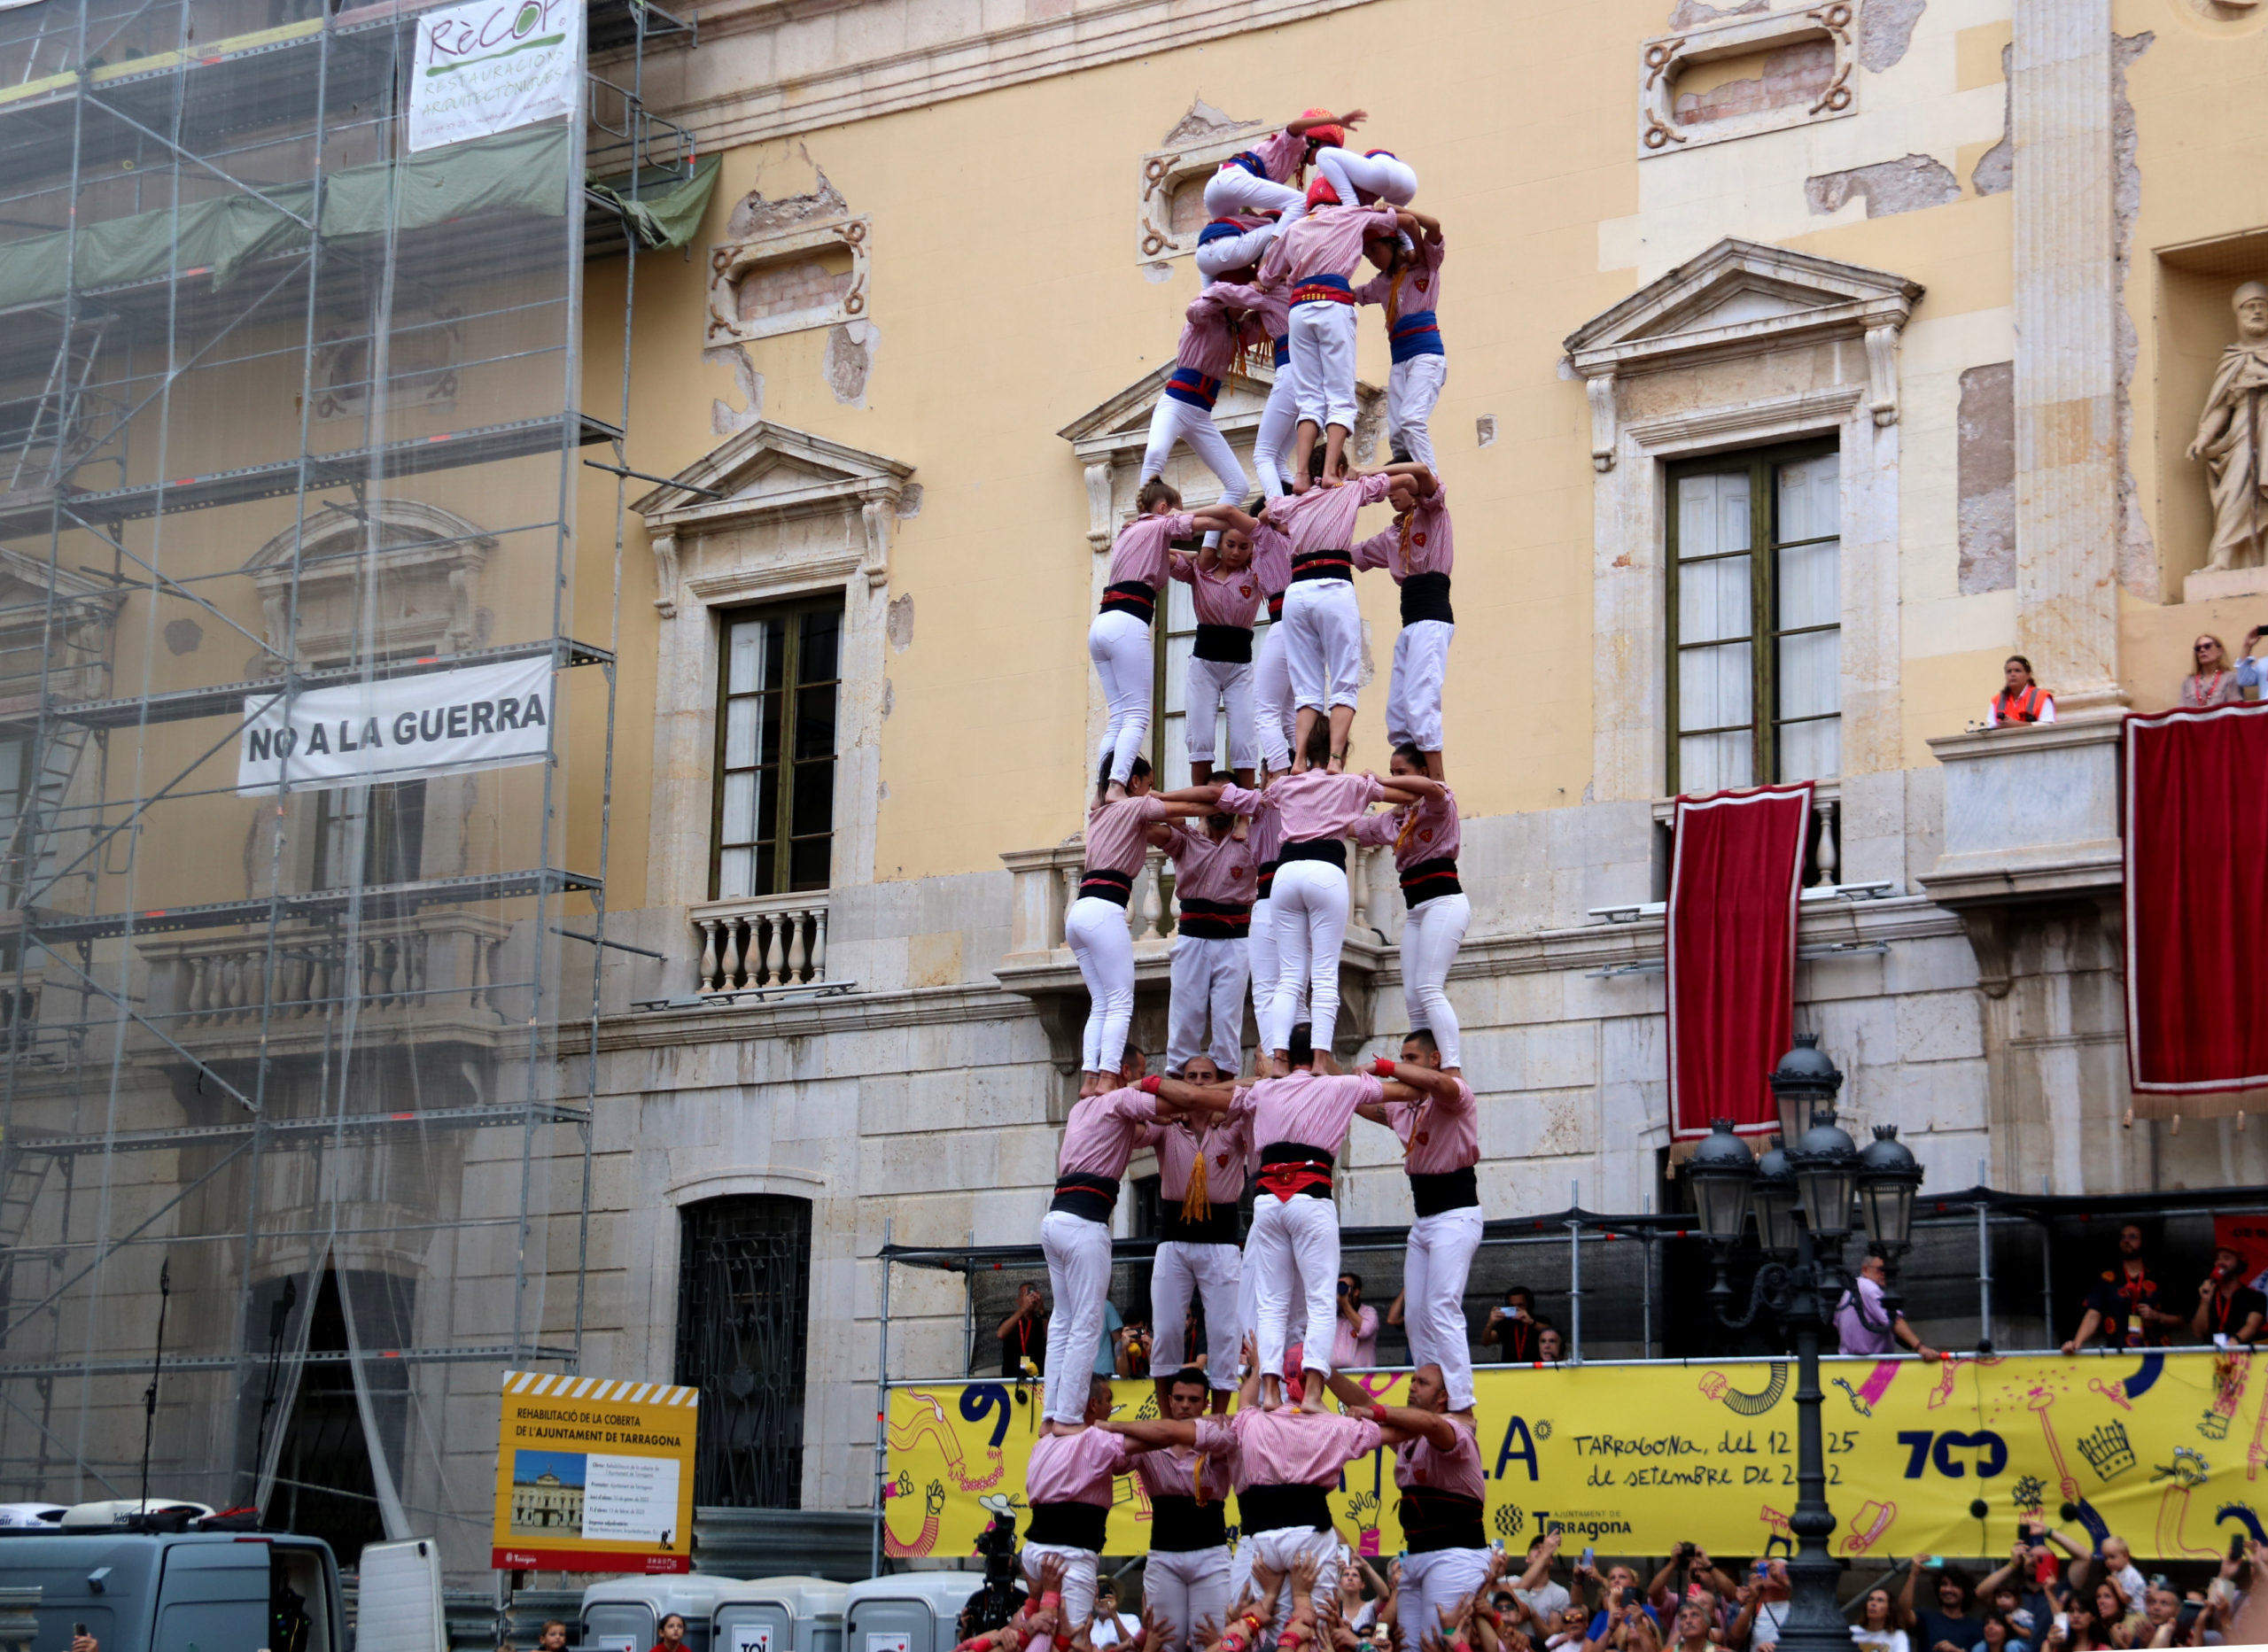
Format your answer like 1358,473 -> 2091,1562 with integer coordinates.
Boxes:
490,1371 -> 701,1572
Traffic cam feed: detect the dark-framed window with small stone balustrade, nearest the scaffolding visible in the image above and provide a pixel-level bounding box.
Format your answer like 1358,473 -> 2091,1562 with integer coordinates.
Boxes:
710,596 -> 843,900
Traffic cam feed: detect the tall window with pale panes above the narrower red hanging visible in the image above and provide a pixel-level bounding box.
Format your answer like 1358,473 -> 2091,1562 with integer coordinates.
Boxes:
1667,444 -> 1842,793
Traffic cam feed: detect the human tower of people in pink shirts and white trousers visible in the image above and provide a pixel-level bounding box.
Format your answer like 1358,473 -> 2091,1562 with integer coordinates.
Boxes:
984,109 -> 1490,1652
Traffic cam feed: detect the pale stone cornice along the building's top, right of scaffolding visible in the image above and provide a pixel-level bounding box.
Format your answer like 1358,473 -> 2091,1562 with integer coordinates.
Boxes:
594,0 -> 1370,151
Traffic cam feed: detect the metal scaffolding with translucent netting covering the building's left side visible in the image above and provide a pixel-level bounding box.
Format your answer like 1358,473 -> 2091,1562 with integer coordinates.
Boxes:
0,0 -> 714,1578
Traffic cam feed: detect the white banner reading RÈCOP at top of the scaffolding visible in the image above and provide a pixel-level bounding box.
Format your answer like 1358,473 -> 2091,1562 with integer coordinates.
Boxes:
410,0 -> 583,151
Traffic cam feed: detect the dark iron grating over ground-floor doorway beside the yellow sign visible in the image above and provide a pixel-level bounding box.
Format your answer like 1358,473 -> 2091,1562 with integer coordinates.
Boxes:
676,1194 -> 812,1509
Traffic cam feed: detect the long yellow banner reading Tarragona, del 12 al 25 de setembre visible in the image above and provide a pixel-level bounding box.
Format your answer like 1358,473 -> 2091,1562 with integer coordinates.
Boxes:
884,1348 -> 2268,1559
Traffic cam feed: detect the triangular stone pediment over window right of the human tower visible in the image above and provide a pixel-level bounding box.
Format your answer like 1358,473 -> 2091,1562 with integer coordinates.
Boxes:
1567,238 -> 1921,378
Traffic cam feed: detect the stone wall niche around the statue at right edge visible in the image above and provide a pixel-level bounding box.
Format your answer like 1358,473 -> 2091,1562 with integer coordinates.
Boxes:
2157,229 -> 2268,602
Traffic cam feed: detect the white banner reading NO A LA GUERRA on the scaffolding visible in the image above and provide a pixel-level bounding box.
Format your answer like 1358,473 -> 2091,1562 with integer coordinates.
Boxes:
236,655 -> 551,798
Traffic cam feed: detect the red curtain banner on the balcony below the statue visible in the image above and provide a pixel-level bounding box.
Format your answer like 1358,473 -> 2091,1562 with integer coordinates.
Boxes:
2125,705 -> 2268,1095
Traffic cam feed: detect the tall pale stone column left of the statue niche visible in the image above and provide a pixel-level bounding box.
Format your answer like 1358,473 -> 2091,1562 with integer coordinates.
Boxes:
2009,0 -> 2125,721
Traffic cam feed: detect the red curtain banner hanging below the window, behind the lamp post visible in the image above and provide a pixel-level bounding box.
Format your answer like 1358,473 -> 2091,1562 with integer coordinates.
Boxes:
1667,782 -> 1812,1142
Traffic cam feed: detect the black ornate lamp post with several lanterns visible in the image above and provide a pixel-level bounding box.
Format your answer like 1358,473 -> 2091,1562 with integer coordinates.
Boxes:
1685,1034 -> 1921,1652
